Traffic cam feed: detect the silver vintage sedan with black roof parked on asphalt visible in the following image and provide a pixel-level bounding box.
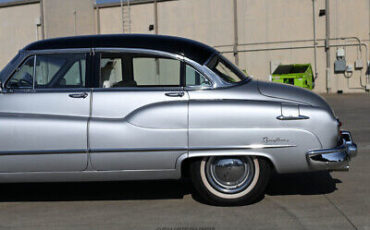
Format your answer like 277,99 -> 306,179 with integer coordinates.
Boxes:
0,35 -> 357,205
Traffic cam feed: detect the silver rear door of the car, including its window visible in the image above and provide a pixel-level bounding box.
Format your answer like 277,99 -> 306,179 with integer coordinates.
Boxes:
89,51 -> 188,171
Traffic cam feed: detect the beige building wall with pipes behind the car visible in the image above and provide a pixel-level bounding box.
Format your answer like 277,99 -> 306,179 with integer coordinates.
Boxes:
0,0 -> 370,93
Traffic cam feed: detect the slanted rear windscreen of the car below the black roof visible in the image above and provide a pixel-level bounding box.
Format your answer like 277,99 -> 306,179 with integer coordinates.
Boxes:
207,55 -> 248,83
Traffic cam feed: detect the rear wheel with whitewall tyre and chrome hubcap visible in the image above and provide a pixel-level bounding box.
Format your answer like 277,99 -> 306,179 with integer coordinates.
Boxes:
190,156 -> 271,205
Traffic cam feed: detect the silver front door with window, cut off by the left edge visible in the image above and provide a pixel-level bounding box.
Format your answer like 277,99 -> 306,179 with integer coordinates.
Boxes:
0,53 -> 91,173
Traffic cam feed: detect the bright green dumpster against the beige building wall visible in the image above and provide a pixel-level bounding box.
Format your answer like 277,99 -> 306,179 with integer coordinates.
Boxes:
272,64 -> 314,89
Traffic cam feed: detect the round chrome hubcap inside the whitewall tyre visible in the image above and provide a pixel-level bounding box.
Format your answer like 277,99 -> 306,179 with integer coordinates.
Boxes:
205,157 -> 254,194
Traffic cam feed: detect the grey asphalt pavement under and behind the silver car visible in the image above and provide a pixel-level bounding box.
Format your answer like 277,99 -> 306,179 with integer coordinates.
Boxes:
0,94 -> 370,230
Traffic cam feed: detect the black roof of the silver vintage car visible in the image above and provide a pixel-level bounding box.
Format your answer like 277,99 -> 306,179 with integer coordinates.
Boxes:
24,34 -> 217,64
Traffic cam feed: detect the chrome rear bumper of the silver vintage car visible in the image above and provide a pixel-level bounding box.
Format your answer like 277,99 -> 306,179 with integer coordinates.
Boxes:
306,131 -> 357,171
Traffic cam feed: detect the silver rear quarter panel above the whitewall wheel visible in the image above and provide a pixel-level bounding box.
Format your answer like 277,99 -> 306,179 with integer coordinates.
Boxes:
189,87 -> 335,173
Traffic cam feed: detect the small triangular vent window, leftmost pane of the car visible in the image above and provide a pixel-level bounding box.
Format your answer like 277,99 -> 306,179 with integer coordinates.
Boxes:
6,56 -> 35,89
